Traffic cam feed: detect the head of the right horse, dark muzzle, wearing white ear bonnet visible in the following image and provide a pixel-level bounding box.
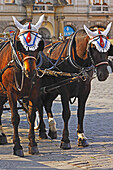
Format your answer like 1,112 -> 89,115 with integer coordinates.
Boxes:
84,23 -> 112,81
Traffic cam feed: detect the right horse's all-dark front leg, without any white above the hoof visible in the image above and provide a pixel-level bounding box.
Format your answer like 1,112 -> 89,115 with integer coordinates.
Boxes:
60,95 -> 71,149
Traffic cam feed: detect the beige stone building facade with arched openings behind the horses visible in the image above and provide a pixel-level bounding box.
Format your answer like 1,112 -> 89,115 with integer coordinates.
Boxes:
0,0 -> 113,41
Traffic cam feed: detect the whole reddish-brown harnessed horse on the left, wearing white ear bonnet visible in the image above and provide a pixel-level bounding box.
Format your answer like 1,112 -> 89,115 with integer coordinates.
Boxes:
0,15 -> 44,156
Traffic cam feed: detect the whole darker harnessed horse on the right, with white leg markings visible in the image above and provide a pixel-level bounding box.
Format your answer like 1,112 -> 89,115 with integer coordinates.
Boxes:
38,23 -> 113,149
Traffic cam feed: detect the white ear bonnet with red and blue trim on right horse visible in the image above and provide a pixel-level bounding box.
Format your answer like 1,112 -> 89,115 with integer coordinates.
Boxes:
84,22 -> 112,52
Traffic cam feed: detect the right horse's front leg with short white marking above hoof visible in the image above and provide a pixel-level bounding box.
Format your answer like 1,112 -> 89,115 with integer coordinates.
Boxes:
77,82 -> 90,147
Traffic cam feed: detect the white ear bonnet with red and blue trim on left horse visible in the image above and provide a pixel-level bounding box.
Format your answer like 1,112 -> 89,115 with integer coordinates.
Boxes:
13,15 -> 44,51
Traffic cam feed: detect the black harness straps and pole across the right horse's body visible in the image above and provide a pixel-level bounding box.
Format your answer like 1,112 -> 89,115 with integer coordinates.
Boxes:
40,32 -> 108,93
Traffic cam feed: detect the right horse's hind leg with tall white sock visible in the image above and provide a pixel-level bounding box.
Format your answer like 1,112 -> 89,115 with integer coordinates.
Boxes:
44,94 -> 57,139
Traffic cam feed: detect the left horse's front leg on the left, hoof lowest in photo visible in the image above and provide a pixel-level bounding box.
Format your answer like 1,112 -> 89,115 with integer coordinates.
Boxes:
8,92 -> 24,157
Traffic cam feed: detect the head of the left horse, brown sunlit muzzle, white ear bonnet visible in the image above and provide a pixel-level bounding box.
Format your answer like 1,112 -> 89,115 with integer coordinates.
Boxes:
13,15 -> 44,78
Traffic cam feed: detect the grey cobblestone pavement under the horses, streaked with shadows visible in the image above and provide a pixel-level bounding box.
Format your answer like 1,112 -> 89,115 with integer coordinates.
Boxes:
0,74 -> 113,170
